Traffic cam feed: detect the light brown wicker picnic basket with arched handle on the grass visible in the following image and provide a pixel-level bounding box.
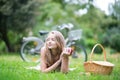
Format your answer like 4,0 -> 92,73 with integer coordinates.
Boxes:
84,44 -> 114,74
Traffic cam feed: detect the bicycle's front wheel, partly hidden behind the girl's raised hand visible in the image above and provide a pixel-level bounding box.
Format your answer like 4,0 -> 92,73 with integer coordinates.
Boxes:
72,45 -> 87,63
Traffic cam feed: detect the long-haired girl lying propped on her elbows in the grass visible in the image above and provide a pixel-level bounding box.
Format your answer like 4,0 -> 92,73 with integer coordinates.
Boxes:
41,31 -> 72,73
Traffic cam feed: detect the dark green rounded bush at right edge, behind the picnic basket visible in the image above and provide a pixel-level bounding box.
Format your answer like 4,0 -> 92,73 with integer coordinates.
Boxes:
102,27 -> 120,52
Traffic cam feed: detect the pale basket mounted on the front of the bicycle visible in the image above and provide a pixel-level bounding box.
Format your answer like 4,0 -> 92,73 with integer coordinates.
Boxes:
68,29 -> 82,40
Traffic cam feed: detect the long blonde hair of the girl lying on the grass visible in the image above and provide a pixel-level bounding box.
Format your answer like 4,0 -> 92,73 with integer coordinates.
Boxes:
45,31 -> 65,66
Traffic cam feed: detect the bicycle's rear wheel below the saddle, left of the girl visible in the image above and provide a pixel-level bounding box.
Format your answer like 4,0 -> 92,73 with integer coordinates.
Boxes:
21,40 -> 43,62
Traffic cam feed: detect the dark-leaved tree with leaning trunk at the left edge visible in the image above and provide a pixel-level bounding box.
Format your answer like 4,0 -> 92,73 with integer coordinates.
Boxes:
0,0 -> 36,52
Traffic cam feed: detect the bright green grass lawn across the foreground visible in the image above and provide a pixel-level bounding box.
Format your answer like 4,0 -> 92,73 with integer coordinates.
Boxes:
0,54 -> 120,80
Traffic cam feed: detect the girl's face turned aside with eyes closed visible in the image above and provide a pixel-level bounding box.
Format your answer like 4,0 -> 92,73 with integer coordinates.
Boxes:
46,34 -> 57,49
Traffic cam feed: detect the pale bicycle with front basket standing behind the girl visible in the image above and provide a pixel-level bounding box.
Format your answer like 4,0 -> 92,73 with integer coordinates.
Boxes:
20,24 -> 87,62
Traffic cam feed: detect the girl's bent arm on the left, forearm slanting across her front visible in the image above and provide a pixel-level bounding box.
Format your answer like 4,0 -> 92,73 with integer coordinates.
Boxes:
41,48 -> 61,73
